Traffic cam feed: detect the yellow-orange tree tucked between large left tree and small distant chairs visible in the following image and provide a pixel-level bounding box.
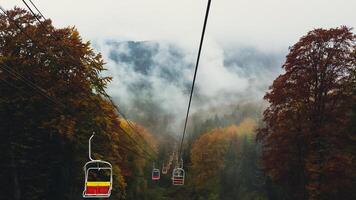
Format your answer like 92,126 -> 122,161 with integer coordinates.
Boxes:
118,119 -> 160,200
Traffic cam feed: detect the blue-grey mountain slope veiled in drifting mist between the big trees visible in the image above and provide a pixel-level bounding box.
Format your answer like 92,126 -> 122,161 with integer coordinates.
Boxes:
96,40 -> 283,133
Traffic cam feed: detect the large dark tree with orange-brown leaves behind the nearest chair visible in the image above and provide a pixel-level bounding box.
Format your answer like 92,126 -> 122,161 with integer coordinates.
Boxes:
0,8 -> 125,200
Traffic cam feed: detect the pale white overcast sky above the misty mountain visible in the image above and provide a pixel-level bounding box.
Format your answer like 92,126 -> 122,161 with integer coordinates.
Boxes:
1,0 -> 356,50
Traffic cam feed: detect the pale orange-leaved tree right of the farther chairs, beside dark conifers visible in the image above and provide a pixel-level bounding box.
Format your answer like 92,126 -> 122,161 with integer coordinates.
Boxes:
191,119 -> 256,193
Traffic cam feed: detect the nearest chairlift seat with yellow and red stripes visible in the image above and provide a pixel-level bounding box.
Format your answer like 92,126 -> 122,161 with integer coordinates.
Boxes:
83,160 -> 112,198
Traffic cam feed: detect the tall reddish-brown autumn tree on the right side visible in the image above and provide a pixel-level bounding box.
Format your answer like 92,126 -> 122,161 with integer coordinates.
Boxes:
257,27 -> 356,199
